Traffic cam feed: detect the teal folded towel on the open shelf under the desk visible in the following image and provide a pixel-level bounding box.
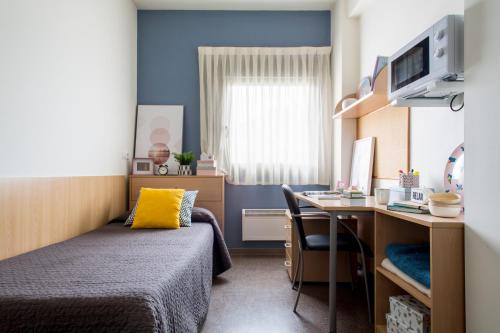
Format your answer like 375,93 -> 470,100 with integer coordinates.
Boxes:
385,243 -> 431,288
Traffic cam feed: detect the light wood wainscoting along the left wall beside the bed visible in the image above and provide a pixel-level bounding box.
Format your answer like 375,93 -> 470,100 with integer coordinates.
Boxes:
0,176 -> 127,259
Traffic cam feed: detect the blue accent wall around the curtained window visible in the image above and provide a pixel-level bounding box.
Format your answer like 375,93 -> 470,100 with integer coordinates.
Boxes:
137,10 -> 330,248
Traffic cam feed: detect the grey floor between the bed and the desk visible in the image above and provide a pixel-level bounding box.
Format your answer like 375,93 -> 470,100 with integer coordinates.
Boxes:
202,256 -> 373,333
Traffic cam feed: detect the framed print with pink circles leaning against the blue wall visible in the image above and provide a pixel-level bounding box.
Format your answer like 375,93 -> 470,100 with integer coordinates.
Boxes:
134,105 -> 184,170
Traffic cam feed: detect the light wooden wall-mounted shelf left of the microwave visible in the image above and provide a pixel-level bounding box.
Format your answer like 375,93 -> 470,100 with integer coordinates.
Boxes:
333,67 -> 390,119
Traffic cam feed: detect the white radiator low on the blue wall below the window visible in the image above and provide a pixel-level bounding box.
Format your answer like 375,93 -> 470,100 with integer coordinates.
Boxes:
241,209 -> 288,241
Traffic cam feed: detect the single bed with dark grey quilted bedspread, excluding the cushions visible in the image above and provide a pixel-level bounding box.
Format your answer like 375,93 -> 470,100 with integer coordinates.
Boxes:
0,208 -> 231,332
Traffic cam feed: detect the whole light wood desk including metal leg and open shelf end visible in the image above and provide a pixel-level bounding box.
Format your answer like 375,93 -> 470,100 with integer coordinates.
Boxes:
295,193 -> 465,333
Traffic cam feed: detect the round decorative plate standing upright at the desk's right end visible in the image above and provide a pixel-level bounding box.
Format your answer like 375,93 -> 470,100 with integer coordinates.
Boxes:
444,143 -> 465,206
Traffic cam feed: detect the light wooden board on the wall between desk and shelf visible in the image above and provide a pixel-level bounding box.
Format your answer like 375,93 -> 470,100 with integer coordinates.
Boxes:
357,107 -> 410,179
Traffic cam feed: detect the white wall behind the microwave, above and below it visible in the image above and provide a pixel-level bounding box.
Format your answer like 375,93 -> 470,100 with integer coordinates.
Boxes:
360,0 -> 464,189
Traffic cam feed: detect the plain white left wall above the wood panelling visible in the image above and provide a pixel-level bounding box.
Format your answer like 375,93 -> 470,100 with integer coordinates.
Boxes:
0,0 -> 137,177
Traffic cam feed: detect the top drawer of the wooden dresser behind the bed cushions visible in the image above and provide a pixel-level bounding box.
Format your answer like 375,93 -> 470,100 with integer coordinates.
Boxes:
130,176 -> 224,201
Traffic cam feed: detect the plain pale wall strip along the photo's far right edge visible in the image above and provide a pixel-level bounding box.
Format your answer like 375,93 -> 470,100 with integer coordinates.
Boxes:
465,0 -> 500,333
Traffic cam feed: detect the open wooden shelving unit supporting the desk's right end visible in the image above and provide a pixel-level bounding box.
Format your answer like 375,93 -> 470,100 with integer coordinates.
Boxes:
374,209 -> 465,333
